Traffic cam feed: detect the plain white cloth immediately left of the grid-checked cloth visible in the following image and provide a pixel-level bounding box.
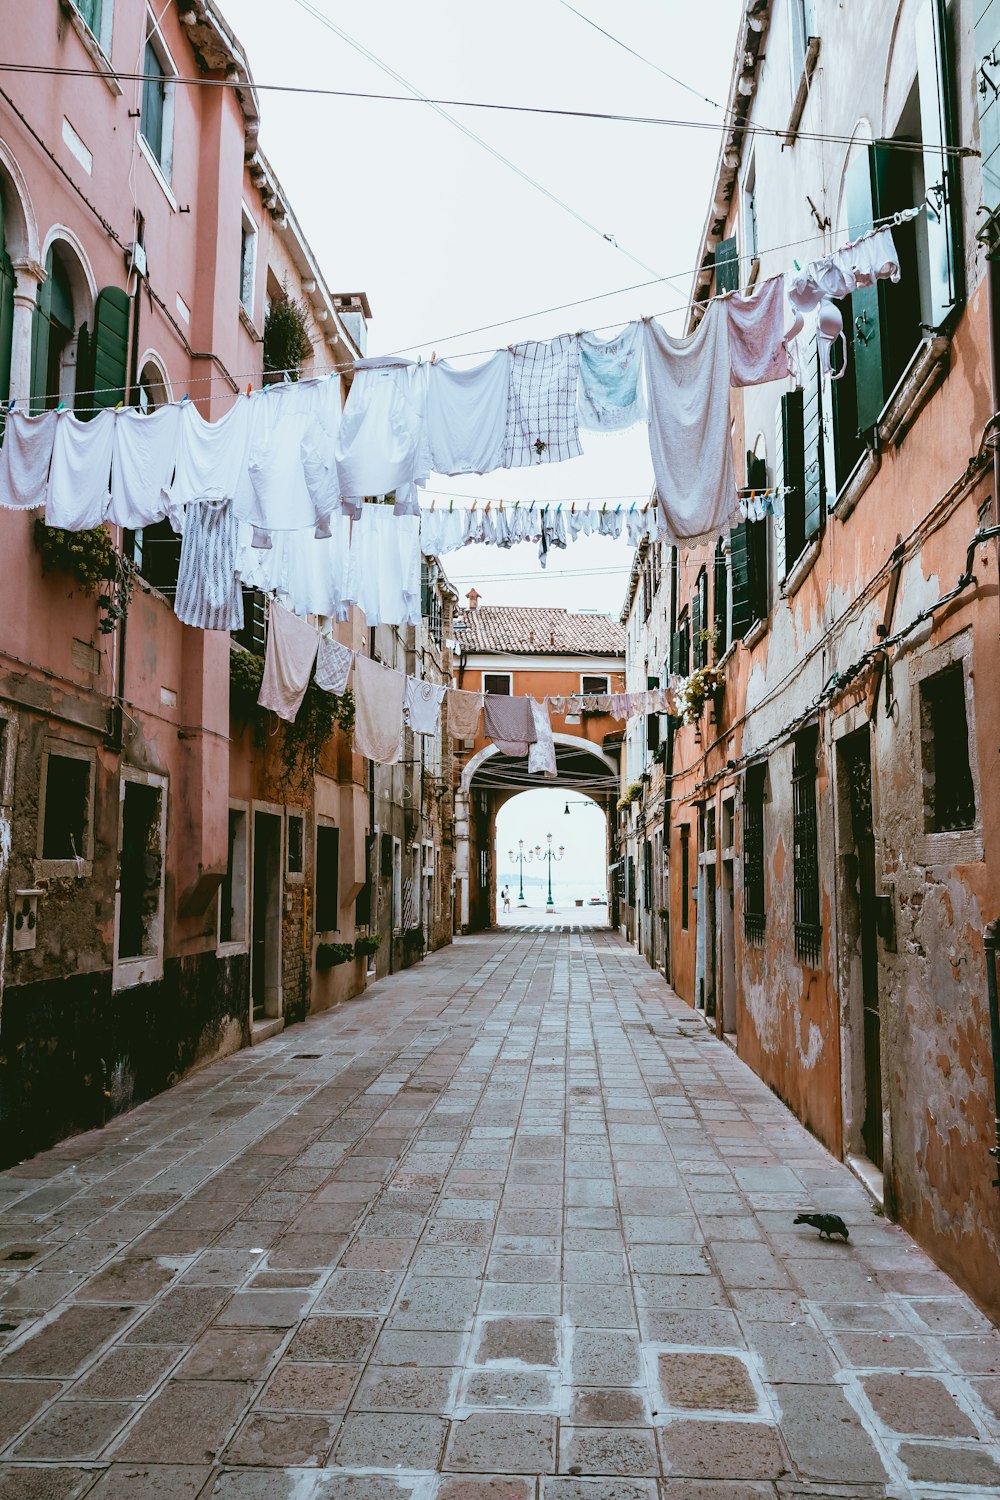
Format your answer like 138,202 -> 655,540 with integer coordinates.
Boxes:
426,350 -> 513,474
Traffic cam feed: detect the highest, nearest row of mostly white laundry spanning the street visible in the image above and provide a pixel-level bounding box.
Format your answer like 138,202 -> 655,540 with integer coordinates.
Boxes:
0,219 -> 917,551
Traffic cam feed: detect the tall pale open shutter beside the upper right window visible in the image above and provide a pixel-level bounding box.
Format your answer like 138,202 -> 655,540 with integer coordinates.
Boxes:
916,0 -> 963,329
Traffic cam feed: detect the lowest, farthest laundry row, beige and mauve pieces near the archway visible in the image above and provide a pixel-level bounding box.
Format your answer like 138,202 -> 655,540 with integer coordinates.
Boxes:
258,602 -> 679,776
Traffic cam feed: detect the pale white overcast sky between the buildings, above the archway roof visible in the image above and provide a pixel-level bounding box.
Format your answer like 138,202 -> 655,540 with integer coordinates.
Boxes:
225,0 -> 739,621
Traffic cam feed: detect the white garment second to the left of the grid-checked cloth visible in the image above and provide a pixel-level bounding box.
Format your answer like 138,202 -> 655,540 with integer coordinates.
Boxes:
334,359 -> 430,501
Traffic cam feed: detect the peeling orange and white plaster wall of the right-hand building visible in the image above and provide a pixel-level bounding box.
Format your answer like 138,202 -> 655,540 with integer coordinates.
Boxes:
638,0 -> 1000,1317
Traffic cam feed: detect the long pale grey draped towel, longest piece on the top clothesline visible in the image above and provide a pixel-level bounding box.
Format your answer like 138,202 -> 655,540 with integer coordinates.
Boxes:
643,302 -> 736,546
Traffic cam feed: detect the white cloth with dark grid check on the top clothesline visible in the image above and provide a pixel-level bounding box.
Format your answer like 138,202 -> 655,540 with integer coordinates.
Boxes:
502,333 -> 583,468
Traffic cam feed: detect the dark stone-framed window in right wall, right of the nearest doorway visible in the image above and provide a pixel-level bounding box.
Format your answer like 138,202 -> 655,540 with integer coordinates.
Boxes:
921,662 -> 976,834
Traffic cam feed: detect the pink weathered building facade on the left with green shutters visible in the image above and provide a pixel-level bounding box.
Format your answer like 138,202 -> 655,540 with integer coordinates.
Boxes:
0,0 -> 369,1161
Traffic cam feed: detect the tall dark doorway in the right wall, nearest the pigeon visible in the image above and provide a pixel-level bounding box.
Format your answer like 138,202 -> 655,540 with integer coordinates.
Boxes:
840,729 -> 883,1172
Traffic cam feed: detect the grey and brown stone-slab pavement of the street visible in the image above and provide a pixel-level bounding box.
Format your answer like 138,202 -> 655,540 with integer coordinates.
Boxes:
0,932 -> 1000,1500
